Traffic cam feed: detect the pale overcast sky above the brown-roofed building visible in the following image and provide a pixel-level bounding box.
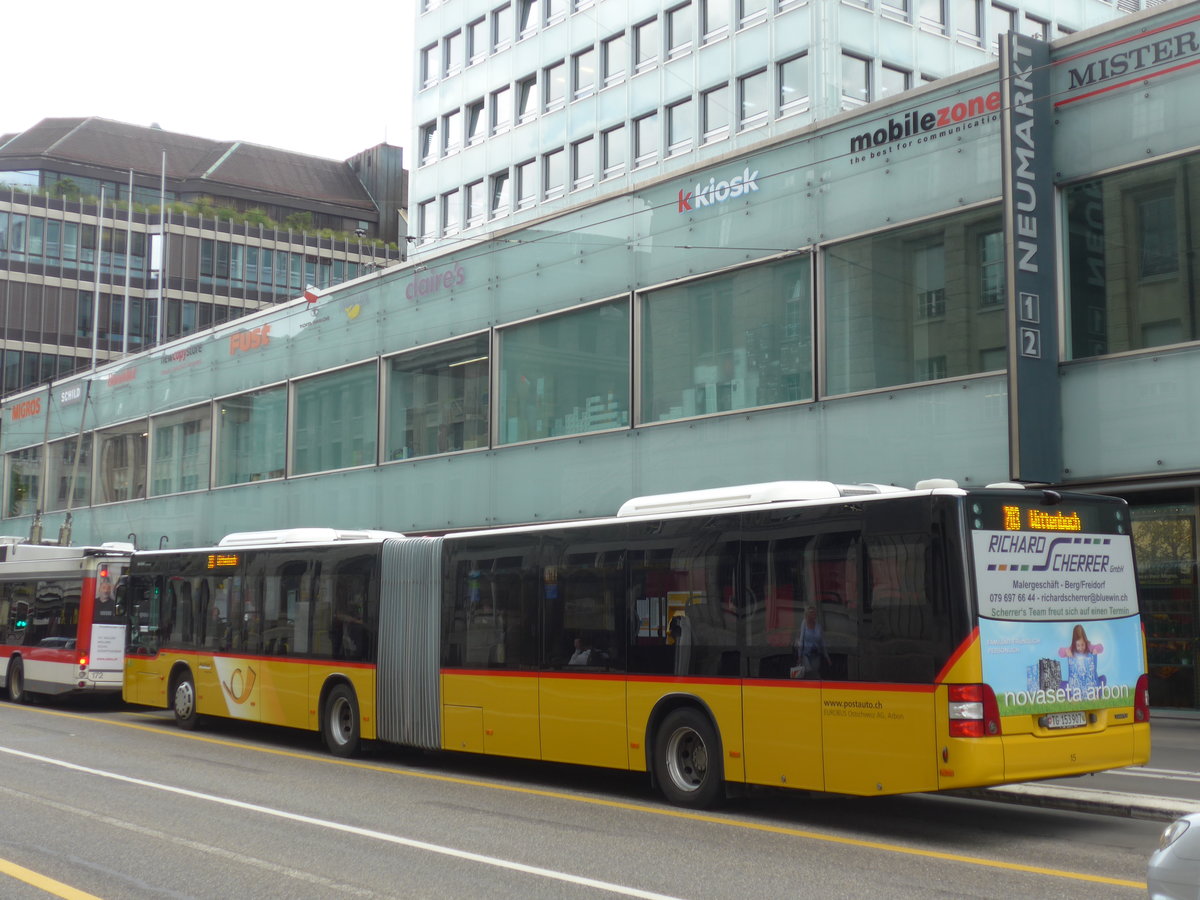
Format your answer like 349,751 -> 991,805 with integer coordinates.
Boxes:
0,0 -> 415,160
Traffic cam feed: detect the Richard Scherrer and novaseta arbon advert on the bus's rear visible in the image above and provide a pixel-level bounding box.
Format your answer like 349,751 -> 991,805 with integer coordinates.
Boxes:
973,532 -> 1145,726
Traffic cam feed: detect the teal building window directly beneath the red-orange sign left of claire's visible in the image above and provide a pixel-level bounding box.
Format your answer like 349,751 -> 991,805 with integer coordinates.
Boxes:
216,385 -> 288,487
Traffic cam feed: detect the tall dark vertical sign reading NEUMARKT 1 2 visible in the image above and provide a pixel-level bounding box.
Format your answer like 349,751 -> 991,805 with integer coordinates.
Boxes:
1000,32 -> 1062,484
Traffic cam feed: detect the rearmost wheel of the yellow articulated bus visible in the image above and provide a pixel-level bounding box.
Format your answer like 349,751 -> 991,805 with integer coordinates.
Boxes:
654,707 -> 724,809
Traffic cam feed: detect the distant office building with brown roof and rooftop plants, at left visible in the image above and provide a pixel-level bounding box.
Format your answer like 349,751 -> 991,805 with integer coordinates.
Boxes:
0,118 -> 404,395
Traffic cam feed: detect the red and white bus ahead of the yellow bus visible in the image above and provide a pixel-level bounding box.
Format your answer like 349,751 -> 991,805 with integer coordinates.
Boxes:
0,539 -> 133,703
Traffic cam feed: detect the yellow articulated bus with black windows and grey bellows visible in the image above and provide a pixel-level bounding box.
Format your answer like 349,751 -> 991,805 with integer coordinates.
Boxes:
125,481 -> 1150,808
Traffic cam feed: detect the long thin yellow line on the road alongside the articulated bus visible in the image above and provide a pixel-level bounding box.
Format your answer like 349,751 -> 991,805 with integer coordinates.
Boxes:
14,707 -> 1146,896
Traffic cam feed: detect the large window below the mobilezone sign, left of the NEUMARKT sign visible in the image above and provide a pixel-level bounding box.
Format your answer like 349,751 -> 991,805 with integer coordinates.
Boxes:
824,209 -> 1007,394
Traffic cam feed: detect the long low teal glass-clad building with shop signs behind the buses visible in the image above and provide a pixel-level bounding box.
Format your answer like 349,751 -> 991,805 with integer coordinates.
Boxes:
7,4 -> 1200,707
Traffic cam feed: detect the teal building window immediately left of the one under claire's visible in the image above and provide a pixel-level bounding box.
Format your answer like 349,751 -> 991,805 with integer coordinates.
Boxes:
292,362 -> 378,475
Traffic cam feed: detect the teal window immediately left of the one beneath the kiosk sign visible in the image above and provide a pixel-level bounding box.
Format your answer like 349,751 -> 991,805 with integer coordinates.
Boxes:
498,300 -> 630,444
